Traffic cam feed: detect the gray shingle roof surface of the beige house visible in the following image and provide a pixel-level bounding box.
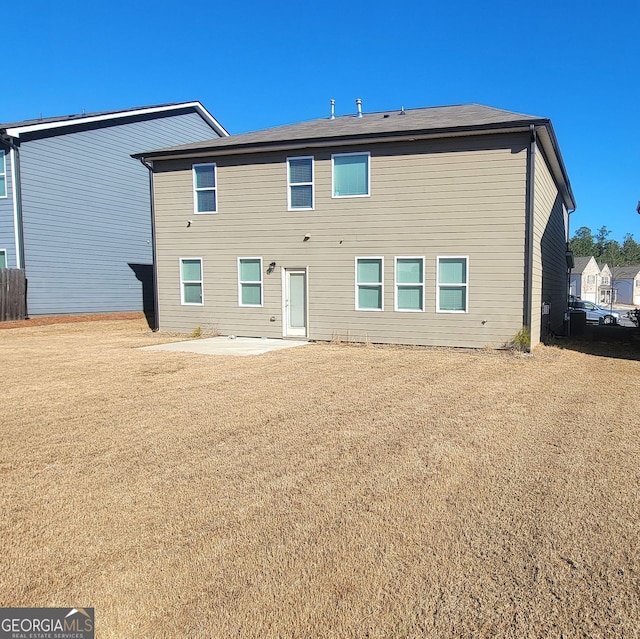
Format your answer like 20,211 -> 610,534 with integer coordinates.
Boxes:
136,104 -> 549,159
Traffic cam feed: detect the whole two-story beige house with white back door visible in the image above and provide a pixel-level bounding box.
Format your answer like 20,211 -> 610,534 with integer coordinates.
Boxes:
135,105 -> 575,347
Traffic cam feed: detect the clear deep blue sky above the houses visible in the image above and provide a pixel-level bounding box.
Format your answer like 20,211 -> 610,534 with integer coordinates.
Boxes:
6,0 -> 640,240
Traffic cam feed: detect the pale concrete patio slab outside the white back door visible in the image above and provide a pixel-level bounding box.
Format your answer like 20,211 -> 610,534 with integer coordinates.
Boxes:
141,337 -> 309,357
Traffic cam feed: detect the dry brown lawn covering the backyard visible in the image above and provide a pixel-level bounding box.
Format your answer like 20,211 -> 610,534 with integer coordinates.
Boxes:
0,320 -> 640,639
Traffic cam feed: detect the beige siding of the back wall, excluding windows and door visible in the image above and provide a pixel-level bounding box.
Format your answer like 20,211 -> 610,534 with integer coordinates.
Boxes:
154,135 -> 526,347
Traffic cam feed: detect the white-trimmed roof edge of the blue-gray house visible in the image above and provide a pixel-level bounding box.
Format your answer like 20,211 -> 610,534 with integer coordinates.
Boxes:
0,100 -> 229,138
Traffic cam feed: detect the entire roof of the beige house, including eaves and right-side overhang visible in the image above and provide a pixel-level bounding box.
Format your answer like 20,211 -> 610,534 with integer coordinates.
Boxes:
133,104 -> 576,210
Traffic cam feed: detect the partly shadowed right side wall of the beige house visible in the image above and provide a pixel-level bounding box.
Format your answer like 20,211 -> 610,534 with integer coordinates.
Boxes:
531,148 -> 568,346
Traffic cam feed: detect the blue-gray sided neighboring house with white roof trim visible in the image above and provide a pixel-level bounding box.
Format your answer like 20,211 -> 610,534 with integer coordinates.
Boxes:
0,102 -> 228,315
